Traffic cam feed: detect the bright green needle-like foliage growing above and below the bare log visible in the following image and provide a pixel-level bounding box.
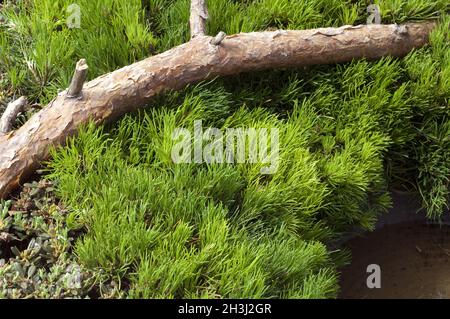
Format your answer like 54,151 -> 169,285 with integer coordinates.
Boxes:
0,0 -> 450,298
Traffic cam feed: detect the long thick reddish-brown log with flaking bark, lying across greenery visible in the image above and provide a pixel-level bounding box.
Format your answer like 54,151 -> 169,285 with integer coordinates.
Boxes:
0,22 -> 435,197
